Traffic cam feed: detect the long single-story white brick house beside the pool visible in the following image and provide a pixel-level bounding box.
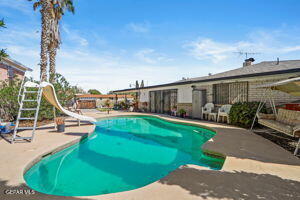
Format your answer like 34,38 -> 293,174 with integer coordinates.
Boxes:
114,59 -> 300,118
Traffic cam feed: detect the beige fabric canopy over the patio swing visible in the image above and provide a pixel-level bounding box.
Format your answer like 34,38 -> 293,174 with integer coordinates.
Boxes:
257,77 -> 300,96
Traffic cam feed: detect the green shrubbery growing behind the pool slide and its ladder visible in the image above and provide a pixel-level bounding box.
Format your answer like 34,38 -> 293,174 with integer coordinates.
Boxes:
0,74 -> 77,121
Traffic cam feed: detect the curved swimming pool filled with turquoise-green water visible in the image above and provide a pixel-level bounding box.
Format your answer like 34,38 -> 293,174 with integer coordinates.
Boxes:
24,116 -> 224,196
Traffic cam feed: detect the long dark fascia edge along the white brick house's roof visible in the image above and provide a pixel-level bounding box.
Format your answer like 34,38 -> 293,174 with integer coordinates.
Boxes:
113,68 -> 300,92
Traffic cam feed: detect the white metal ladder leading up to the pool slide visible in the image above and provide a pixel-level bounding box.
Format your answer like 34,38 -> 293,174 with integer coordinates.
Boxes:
10,82 -> 43,143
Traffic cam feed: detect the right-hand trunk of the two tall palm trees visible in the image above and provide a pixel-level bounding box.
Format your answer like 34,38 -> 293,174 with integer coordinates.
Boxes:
48,0 -> 74,82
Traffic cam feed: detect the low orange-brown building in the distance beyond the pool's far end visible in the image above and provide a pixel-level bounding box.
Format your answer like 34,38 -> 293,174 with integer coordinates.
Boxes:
76,94 -> 134,109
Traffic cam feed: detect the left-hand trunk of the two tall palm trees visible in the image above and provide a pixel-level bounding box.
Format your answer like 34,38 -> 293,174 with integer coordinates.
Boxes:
28,0 -> 51,81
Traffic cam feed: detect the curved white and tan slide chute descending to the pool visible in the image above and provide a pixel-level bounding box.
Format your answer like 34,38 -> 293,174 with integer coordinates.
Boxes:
24,81 -> 96,122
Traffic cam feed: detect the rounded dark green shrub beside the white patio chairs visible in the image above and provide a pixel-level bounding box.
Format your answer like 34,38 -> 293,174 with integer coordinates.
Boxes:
229,102 -> 266,128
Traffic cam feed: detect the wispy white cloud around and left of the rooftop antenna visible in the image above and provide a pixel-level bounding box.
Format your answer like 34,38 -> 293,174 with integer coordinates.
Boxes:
183,31 -> 300,63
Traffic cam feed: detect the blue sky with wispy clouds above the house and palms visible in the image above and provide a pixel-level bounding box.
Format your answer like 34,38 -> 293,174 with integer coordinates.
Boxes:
0,0 -> 300,92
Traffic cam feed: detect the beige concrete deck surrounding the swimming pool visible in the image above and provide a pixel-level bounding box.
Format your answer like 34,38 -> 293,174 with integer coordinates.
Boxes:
0,110 -> 300,200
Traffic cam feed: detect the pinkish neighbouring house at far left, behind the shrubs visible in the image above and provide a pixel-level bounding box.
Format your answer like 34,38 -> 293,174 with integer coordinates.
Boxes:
0,57 -> 32,81
